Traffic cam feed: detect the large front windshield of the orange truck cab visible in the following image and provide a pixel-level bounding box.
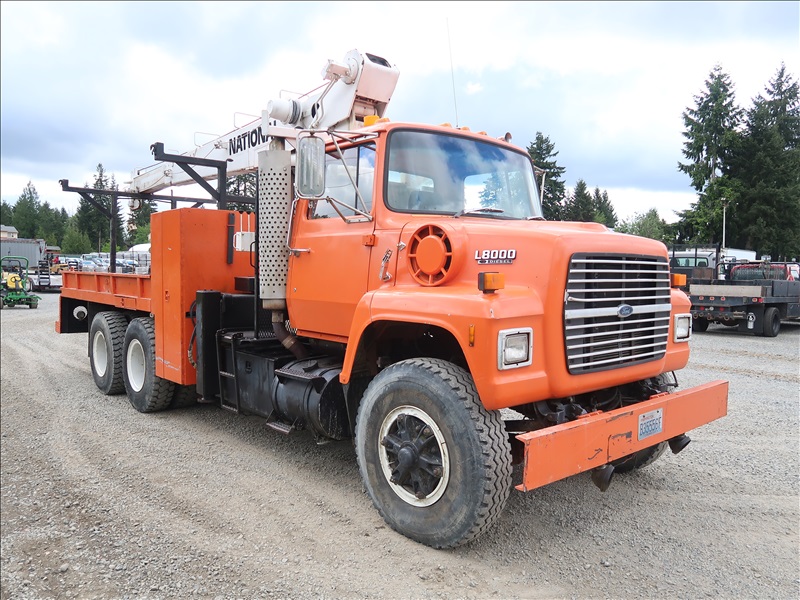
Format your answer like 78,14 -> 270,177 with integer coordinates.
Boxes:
386,130 -> 542,219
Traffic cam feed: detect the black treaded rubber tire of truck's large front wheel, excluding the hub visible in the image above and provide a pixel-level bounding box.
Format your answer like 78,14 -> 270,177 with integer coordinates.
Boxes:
355,358 -> 511,548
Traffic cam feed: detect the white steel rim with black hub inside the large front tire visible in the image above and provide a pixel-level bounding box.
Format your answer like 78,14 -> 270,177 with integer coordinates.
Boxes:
378,406 -> 450,507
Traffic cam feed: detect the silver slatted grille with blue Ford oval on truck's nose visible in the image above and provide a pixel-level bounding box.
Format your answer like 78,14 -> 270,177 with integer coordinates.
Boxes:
564,254 -> 671,375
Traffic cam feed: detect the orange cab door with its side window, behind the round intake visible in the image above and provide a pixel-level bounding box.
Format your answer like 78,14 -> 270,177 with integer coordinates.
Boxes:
286,143 -> 375,341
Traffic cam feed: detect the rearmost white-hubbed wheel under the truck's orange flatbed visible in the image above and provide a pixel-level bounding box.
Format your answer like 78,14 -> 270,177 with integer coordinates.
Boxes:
89,311 -> 128,396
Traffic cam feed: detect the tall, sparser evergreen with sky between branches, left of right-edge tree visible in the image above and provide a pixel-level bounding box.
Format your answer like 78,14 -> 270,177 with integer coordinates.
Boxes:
678,65 -> 742,243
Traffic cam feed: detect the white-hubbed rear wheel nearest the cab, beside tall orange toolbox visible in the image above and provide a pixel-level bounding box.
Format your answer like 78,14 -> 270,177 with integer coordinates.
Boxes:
122,317 -> 175,413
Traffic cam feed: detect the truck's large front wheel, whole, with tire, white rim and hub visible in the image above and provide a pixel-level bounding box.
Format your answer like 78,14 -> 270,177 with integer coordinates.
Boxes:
356,358 -> 511,548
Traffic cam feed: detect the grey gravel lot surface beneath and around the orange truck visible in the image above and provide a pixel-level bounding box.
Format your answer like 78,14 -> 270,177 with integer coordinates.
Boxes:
0,294 -> 800,599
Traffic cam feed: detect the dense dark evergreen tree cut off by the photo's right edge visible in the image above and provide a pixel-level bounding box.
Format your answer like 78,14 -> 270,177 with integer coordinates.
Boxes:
727,65 -> 800,260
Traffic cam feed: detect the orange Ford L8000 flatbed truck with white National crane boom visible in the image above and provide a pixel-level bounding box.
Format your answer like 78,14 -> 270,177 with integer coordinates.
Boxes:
56,50 -> 728,548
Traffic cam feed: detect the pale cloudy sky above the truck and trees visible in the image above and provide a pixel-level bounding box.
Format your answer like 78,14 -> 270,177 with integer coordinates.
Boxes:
0,0 -> 800,222
